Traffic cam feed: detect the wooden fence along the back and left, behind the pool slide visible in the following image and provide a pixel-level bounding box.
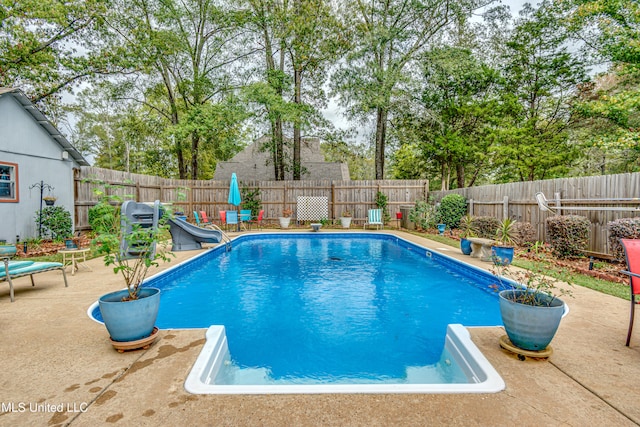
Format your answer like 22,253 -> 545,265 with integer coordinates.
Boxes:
74,167 -> 429,230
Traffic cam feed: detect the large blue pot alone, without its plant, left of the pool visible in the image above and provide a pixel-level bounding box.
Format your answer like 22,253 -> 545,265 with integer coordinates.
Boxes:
98,288 -> 160,342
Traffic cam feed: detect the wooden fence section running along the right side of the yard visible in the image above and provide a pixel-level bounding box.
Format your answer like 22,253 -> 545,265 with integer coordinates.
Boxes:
429,173 -> 640,254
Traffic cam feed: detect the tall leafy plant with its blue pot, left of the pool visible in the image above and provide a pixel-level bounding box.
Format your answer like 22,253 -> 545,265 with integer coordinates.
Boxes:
92,187 -> 172,350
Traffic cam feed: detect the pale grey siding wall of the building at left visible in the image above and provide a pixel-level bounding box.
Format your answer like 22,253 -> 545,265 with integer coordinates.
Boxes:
0,96 -> 75,243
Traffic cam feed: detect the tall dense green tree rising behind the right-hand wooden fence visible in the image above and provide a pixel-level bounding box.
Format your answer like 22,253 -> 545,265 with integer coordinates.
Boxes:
493,2 -> 587,182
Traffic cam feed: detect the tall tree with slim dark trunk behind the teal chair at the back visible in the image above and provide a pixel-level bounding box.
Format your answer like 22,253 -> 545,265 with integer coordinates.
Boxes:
333,0 -> 488,179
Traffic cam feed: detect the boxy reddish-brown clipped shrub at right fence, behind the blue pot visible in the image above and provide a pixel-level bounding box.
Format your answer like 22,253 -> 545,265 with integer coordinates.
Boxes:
547,215 -> 591,258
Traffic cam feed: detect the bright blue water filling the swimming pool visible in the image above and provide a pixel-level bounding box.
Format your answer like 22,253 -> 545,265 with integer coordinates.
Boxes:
94,233 -> 508,383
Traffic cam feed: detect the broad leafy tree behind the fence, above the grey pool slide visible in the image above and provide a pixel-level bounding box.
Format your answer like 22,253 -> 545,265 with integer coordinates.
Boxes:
103,0 -> 252,179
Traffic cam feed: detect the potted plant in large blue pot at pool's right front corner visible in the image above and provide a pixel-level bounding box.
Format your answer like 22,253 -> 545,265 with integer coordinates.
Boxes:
492,265 -> 571,352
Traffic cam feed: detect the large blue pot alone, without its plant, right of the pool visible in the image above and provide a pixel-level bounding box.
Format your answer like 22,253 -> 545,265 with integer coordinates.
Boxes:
500,290 -> 564,351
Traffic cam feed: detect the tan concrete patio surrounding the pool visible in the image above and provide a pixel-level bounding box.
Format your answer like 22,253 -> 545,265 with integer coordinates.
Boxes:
0,231 -> 640,426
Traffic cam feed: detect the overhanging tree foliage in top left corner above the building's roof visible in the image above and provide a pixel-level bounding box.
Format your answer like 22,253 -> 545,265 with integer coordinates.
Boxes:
0,0 -> 112,108
